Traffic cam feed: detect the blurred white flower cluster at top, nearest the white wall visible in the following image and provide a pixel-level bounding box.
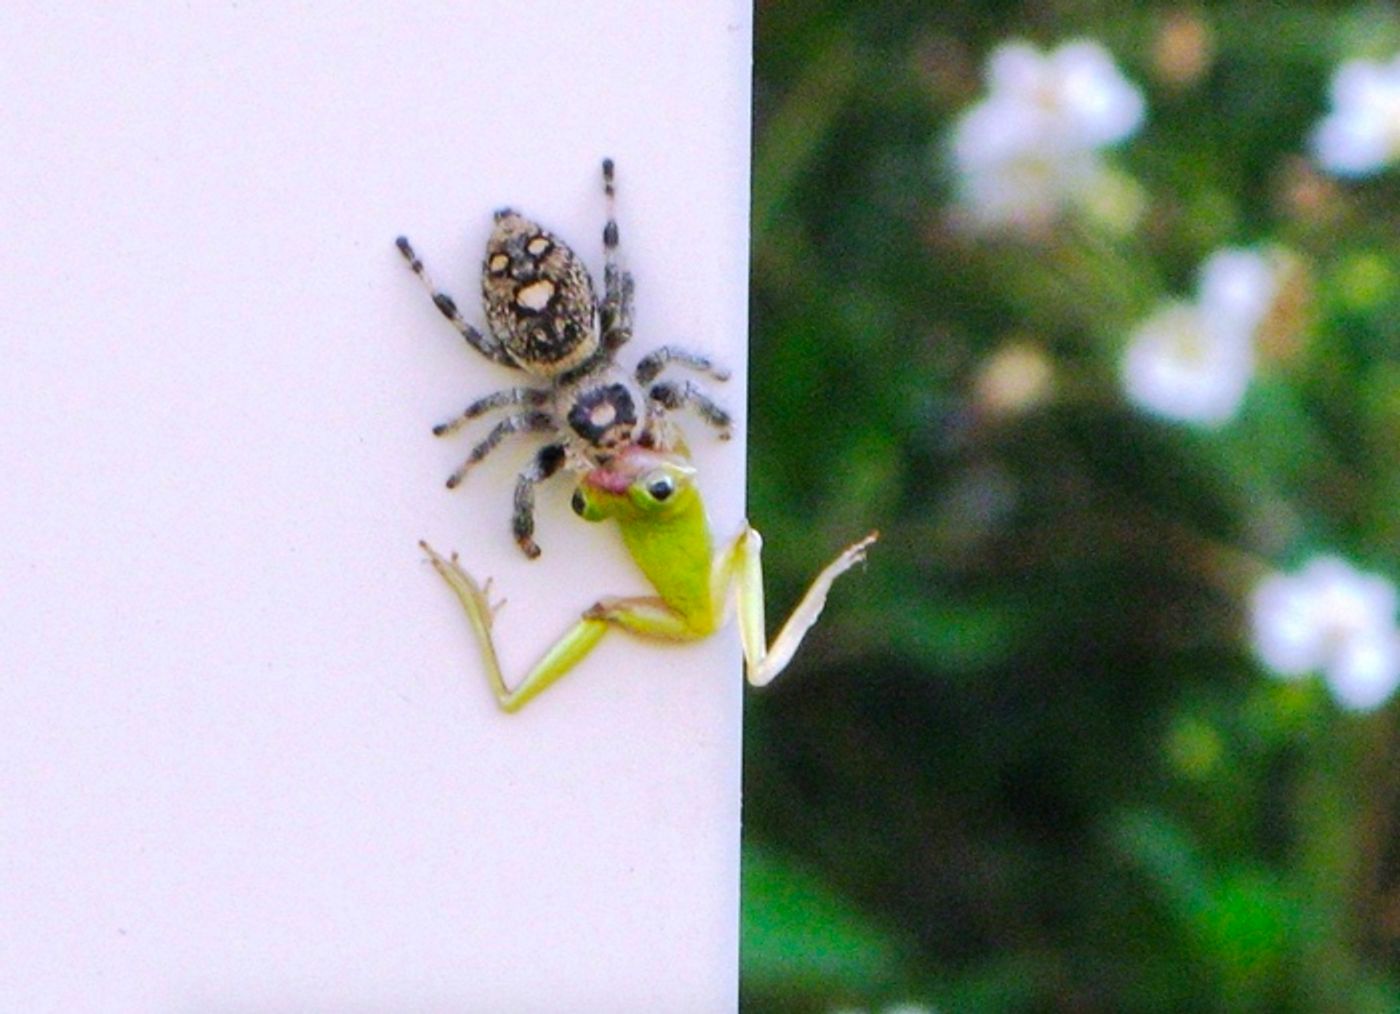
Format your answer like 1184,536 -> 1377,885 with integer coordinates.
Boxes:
949,41 -> 1145,228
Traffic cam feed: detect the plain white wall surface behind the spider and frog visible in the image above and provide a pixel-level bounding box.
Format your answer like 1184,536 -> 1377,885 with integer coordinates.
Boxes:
0,0 -> 750,1011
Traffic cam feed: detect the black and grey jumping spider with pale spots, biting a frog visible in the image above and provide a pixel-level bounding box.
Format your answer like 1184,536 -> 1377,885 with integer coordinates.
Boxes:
398,158 -> 731,557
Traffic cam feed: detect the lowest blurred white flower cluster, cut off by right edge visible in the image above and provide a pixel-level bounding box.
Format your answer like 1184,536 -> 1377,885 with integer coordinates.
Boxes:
1250,556 -> 1400,710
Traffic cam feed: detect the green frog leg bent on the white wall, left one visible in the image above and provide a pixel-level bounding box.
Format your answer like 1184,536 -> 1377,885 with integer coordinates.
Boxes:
419,542 -> 703,711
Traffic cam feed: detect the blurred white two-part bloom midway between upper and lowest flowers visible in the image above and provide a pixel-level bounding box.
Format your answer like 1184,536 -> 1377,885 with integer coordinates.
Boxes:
1123,249 -> 1278,426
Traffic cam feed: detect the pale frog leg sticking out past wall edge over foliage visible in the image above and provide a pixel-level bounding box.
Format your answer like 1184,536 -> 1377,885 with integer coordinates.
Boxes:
711,524 -> 879,686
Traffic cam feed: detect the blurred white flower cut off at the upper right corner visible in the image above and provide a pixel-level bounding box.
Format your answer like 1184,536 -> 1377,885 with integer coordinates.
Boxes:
1312,55 -> 1400,176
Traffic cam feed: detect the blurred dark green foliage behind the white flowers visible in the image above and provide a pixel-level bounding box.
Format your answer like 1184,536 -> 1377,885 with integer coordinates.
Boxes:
742,0 -> 1400,1011
